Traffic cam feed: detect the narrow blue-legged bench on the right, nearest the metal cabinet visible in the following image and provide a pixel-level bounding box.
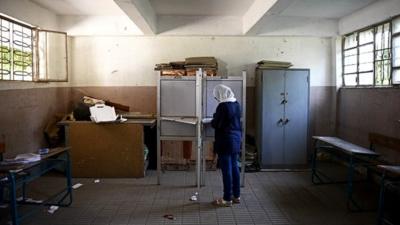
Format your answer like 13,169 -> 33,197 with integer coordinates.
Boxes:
311,136 -> 379,211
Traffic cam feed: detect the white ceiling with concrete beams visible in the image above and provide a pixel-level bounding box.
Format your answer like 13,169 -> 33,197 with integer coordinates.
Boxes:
31,0 -> 378,35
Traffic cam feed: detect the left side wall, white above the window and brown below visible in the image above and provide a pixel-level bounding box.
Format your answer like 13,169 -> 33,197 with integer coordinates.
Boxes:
0,0 -> 71,157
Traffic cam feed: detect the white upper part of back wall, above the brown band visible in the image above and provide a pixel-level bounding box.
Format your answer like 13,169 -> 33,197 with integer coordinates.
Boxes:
70,36 -> 335,86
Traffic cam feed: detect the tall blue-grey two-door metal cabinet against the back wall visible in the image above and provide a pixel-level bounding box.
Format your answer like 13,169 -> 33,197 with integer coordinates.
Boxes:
256,69 -> 309,168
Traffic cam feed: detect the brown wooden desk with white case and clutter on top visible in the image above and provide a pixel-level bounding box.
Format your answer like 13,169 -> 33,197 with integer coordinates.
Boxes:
58,119 -> 156,178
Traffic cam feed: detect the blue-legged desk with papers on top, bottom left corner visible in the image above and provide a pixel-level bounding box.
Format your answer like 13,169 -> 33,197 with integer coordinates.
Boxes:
0,147 -> 72,225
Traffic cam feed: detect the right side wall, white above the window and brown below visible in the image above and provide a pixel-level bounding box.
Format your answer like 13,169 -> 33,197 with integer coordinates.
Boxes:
337,0 -> 400,156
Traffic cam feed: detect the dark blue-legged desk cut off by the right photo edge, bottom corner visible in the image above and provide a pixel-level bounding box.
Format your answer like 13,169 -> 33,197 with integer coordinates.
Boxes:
378,165 -> 400,225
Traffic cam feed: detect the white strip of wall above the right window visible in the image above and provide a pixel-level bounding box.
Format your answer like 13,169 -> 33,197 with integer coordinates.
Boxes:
339,0 -> 400,34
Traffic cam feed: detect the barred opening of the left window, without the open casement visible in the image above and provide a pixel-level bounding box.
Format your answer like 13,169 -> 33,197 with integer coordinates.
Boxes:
0,16 -> 33,81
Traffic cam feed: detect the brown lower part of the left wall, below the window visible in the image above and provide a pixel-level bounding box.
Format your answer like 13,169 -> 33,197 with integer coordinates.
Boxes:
0,87 -> 71,157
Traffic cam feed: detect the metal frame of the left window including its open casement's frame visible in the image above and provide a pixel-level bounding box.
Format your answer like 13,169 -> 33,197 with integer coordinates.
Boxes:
0,13 -> 69,82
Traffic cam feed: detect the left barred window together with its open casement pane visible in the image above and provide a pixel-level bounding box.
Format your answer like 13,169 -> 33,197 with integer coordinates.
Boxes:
0,15 -> 68,81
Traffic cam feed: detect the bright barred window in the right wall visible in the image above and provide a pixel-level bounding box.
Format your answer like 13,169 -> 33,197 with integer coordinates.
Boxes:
342,17 -> 400,87
